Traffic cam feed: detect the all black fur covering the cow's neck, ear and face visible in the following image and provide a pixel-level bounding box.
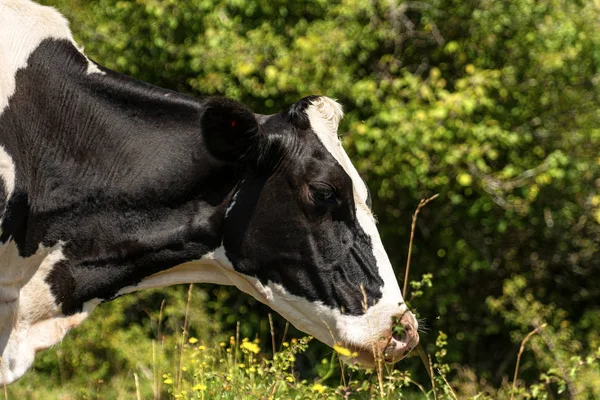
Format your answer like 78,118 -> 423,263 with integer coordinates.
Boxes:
0,40 -> 383,314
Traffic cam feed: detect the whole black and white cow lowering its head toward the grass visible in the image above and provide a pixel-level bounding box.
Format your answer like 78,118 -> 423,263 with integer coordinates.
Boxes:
0,0 -> 418,383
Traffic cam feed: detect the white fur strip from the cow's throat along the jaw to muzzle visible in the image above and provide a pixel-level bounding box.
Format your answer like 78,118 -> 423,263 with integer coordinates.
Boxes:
118,242 -> 418,366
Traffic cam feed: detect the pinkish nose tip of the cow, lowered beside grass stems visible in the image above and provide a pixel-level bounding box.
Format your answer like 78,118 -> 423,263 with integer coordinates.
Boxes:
383,311 -> 419,362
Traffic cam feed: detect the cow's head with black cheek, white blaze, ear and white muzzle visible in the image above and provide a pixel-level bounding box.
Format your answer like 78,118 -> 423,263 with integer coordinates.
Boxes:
203,96 -> 419,366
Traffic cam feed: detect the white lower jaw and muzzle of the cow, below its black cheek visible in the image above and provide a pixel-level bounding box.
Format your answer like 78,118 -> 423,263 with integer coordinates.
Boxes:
216,252 -> 419,367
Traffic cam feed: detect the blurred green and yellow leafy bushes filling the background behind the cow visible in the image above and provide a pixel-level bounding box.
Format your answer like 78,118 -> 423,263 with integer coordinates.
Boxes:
8,0 -> 600,399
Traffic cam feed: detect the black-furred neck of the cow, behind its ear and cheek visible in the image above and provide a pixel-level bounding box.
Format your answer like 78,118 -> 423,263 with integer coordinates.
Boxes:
0,40 -> 237,313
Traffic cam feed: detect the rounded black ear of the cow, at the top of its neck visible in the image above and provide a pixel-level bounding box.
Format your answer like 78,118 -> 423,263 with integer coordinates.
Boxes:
201,97 -> 259,162
